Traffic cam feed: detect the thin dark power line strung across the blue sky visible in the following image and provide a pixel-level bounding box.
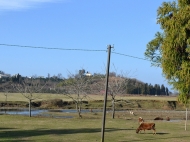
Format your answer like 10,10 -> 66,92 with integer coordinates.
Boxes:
0,44 -> 150,61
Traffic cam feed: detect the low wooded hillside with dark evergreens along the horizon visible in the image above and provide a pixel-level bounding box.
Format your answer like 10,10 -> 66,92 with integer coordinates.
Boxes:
0,73 -> 171,96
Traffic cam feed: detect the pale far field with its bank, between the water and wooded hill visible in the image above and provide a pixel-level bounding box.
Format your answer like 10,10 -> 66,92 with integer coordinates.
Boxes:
0,93 -> 190,110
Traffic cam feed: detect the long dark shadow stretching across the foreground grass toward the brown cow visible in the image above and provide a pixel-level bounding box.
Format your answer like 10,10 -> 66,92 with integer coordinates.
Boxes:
0,128 -> 134,139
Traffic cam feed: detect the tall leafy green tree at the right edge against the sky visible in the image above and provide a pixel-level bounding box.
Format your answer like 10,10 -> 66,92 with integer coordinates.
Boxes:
145,0 -> 190,104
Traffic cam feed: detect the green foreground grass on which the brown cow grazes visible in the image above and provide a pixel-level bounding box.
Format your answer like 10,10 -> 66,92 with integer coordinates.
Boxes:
0,113 -> 190,142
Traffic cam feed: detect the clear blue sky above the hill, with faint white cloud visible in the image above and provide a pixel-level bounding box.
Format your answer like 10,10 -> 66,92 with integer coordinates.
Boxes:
0,0 -> 171,89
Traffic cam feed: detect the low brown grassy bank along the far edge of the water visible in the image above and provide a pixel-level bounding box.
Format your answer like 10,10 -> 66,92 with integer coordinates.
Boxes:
0,99 -> 190,110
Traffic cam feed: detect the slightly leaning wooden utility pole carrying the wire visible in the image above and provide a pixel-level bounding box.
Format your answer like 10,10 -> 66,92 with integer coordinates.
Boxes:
101,45 -> 112,142
